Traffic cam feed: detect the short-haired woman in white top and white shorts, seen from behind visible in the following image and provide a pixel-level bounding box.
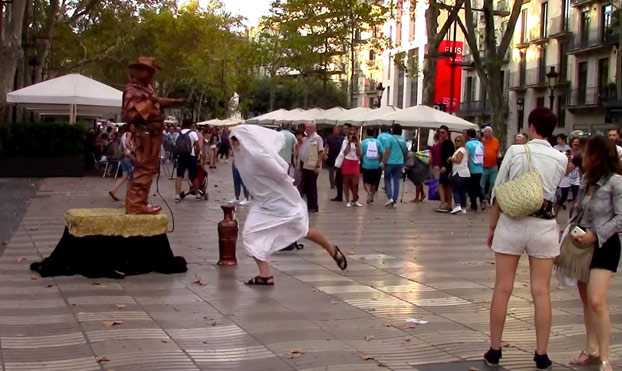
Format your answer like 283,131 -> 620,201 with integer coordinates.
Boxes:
484,107 -> 568,370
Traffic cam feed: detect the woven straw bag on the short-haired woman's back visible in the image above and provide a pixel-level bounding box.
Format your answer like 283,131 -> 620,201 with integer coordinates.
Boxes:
494,145 -> 544,219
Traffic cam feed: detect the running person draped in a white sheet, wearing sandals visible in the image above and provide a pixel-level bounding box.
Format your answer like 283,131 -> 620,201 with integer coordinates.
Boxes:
231,125 -> 348,285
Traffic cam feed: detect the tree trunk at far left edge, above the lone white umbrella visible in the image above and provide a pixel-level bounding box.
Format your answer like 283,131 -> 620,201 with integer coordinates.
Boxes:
0,0 -> 27,122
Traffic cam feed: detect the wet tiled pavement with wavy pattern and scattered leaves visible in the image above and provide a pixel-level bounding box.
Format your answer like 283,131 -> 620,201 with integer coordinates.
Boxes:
0,164 -> 622,371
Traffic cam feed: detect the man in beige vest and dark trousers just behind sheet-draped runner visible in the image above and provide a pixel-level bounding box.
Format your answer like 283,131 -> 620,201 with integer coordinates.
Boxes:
296,122 -> 324,213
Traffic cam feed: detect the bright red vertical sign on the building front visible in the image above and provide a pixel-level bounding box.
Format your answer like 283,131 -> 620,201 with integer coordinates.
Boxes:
434,41 -> 464,112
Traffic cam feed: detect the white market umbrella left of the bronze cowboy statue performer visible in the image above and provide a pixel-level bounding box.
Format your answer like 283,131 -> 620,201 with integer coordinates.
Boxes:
6,73 -> 123,123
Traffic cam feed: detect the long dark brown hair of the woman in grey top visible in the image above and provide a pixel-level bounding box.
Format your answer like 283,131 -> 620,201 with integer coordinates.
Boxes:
583,135 -> 622,185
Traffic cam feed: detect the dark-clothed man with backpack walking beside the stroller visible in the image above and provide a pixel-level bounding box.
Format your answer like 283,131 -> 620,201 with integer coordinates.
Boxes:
174,120 -> 201,203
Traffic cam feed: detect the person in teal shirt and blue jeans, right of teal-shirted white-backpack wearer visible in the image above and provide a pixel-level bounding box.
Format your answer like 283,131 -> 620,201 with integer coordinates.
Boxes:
378,124 -> 408,208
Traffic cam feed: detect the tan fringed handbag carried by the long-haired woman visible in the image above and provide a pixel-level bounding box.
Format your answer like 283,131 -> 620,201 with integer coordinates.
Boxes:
555,223 -> 596,283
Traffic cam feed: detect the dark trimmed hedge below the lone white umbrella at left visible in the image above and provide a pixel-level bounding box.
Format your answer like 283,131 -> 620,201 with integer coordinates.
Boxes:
0,122 -> 86,157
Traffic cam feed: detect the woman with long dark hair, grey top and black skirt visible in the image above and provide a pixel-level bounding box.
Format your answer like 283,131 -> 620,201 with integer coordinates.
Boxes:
571,136 -> 622,371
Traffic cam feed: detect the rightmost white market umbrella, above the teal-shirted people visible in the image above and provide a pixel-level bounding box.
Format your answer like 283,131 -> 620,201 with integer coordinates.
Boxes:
383,105 -> 479,131
